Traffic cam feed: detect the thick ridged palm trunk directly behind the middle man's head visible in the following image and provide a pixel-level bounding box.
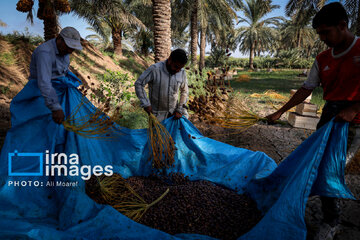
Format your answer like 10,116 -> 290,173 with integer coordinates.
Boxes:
152,0 -> 171,62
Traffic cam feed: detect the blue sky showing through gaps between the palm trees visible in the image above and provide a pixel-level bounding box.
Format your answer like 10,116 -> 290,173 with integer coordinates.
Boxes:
0,0 -> 336,57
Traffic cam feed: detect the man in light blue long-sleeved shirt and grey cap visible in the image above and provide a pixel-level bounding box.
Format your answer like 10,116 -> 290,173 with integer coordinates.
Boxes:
29,27 -> 82,124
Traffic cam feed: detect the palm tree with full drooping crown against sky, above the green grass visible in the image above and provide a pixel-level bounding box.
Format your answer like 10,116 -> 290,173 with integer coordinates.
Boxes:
238,0 -> 284,69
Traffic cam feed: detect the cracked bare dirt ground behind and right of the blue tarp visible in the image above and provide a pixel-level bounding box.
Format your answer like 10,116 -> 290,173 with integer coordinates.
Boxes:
190,116 -> 360,240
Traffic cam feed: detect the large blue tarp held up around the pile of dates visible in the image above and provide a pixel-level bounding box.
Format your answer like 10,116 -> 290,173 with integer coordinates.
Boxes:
0,73 -> 353,240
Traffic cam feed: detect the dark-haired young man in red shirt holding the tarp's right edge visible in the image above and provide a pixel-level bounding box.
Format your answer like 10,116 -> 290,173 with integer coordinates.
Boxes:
266,2 -> 360,239
